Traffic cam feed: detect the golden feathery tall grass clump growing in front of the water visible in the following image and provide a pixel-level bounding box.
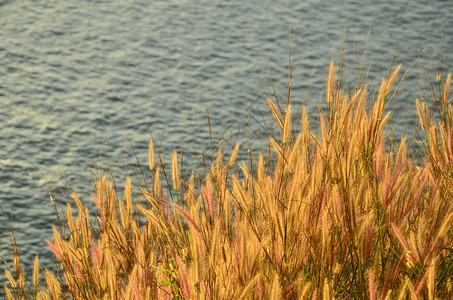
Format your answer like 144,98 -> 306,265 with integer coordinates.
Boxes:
4,55 -> 453,299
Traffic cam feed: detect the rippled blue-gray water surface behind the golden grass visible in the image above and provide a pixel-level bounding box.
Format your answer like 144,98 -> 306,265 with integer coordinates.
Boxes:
0,0 -> 453,285
